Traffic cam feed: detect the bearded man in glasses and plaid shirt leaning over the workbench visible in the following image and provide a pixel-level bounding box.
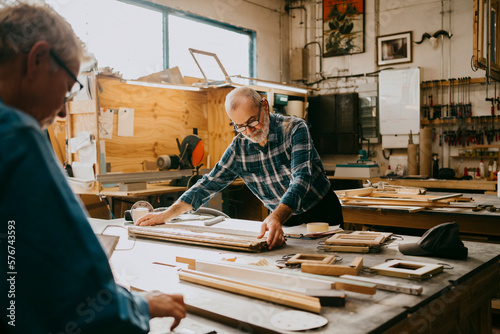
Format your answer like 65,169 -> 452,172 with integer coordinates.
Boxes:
136,87 -> 343,249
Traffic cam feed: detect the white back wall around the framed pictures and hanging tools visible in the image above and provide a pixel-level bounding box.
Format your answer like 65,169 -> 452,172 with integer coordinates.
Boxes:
290,0 -> 500,173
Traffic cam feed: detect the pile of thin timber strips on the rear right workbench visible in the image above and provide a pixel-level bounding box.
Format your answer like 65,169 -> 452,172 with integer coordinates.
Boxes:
340,188 -> 476,209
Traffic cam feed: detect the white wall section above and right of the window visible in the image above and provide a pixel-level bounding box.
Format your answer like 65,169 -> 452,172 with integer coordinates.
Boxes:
151,0 -> 289,81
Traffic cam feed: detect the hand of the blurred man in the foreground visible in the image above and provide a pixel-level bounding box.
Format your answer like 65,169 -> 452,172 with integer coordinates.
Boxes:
144,291 -> 186,331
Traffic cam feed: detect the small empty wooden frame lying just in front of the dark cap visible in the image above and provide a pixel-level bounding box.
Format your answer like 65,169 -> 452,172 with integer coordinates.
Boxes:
370,260 -> 443,280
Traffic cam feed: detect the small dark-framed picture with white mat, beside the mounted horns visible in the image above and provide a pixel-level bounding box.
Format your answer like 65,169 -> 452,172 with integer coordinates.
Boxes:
377,31 -> 412,66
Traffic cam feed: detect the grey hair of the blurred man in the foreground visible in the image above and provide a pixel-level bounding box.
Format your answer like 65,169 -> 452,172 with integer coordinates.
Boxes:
0,2 -> 86,64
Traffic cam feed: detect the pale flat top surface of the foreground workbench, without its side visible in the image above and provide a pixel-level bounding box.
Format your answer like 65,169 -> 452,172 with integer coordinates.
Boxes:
92,220 -> 500,334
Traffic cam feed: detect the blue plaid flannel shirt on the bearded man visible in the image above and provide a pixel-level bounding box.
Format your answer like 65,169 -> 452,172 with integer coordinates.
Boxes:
180,114 -> 330,214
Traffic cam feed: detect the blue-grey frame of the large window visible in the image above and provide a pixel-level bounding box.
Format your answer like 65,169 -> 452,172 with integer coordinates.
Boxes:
117,0 -> 257,77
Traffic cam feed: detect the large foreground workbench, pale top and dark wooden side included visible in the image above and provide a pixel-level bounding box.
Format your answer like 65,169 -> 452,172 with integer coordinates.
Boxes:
91,219 -> 500,334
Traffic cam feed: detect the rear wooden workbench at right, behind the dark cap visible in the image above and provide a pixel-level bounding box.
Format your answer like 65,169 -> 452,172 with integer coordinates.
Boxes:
342,192 -> 500,237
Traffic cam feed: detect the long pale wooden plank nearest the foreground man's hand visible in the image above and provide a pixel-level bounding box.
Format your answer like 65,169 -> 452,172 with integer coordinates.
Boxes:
178,269 -> 321,313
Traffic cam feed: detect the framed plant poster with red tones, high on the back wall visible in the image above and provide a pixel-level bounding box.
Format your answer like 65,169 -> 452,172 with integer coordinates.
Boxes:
323,0 -> 365,57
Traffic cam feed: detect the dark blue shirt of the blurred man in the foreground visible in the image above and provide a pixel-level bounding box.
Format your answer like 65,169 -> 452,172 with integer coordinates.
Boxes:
0,100 -> 150,334
